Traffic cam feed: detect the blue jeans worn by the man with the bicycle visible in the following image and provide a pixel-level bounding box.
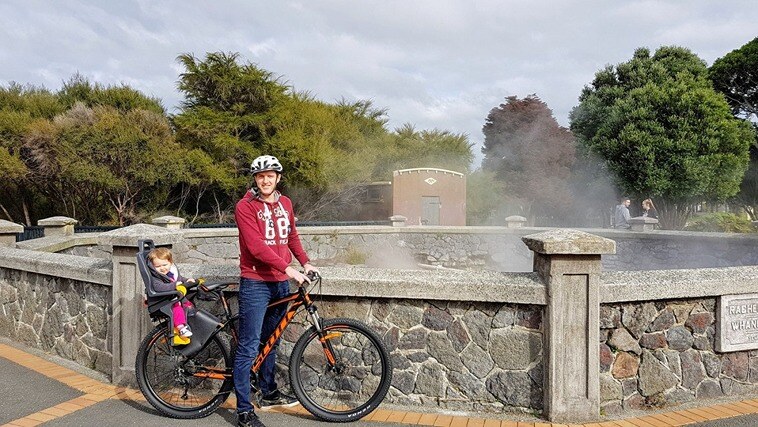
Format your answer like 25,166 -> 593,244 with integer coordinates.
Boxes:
234,278 -> 289,412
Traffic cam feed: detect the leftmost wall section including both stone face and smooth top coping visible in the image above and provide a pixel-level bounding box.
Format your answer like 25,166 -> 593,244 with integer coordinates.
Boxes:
0,246 -> 113,375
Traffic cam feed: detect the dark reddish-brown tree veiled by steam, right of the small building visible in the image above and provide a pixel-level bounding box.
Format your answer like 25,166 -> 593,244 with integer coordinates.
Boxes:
482,95 -> 575,222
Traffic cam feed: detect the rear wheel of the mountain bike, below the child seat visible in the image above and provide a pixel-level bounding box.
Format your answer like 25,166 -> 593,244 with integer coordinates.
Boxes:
135,325 -> 234,419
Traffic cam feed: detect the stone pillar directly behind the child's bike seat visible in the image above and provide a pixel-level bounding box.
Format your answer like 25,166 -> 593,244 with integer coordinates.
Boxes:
98,224 -> 181,386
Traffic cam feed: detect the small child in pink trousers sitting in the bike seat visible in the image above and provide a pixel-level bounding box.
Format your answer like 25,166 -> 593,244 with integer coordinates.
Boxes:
147,248 -> 195,342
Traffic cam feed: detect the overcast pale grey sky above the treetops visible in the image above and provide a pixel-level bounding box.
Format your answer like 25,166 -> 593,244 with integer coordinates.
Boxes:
0,0 -> 758,164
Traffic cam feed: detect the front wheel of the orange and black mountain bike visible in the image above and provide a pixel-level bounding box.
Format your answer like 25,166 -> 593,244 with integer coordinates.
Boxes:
289,318 -> 392,422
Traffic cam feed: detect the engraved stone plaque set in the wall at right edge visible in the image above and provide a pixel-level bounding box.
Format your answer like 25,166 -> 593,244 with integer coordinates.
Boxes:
716,294 -> 758,352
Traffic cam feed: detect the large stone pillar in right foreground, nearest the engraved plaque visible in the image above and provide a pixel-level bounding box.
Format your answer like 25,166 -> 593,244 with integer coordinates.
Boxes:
522,229 -> 616,424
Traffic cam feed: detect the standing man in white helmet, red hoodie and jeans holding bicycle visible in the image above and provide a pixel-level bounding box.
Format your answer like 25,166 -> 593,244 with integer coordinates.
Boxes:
234,156 -> 318,427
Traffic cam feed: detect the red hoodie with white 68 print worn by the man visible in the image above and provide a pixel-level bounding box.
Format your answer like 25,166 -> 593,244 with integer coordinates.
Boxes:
234,191 -> 309,282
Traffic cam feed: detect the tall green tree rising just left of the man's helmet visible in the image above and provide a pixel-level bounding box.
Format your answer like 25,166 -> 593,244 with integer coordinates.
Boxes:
172,52 -> 289,220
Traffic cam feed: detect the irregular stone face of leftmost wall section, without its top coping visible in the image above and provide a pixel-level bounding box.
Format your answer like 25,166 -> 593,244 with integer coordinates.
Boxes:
0,268 -> 112,374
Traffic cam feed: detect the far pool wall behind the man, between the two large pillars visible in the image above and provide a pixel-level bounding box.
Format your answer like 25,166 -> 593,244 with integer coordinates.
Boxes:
176,227 -> 532,271
